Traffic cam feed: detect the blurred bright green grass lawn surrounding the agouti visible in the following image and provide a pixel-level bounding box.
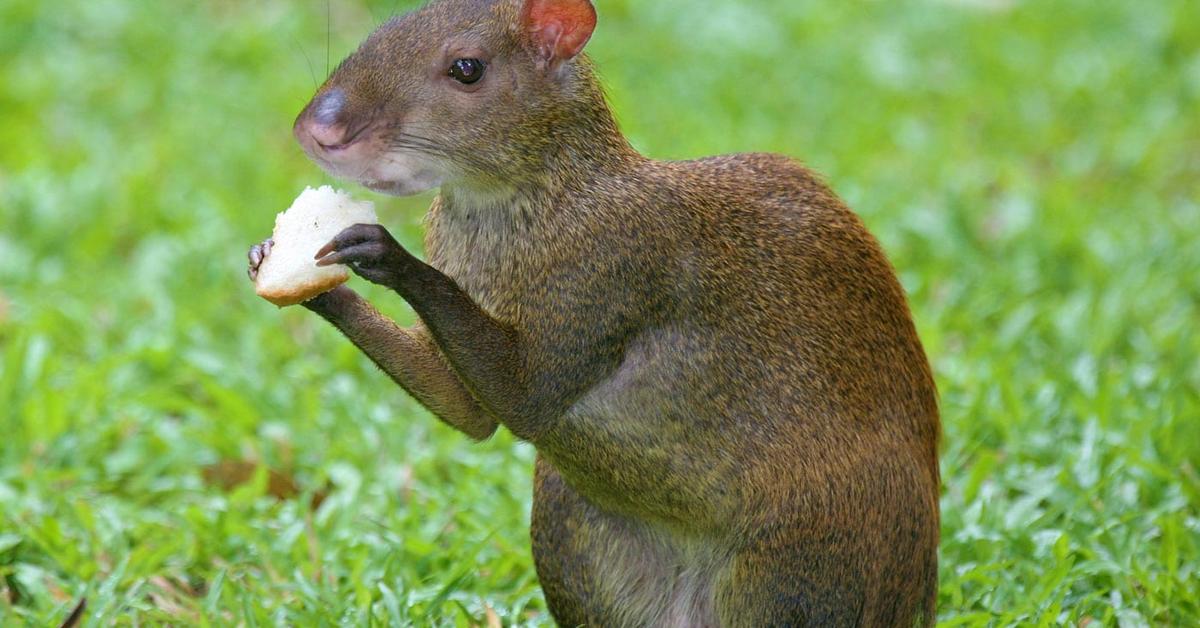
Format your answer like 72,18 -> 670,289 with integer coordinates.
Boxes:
0,0 -> 1200,626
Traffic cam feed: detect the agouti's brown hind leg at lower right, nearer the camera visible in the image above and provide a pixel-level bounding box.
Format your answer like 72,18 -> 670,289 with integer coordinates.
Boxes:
716,461 -> 937,628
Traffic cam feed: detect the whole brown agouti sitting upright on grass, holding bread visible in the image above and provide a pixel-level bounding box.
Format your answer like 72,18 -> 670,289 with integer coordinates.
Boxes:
243,0 -> 940,626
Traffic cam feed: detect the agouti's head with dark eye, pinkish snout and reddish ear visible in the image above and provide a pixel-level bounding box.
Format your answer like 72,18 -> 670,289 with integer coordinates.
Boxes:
294,0 -> 596,195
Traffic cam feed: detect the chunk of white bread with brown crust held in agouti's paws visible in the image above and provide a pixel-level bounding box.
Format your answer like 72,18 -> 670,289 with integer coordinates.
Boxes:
254,185 -> 379,307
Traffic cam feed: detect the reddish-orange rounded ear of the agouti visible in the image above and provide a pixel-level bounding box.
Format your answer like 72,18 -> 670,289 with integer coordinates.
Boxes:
521,0 -> 596,68
